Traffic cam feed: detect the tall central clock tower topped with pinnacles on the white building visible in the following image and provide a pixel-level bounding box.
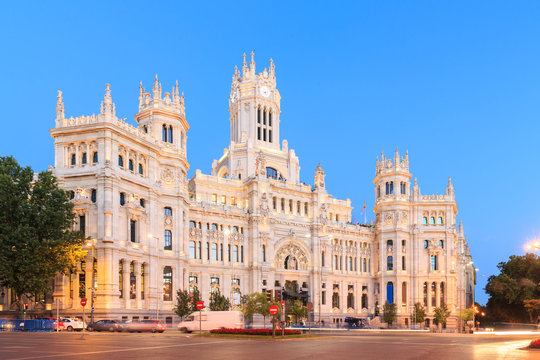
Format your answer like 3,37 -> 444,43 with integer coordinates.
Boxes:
212,52 -> 300,182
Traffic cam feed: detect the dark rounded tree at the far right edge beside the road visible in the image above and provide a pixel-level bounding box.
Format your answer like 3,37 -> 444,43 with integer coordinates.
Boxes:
485,254 -> 540,322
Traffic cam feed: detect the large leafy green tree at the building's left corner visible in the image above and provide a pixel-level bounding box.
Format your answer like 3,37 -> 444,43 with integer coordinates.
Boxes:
0,156 -> 86,310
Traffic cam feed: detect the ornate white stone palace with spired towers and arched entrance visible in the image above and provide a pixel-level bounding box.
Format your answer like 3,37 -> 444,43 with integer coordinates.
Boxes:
0,54 -> 475,326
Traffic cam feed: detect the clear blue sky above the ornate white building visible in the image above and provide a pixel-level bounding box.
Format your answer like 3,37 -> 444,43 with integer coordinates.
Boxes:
0,1 -> 540,303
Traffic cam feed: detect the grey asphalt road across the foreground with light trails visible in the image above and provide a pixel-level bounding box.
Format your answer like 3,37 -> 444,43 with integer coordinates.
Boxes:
0,331 -> 540,360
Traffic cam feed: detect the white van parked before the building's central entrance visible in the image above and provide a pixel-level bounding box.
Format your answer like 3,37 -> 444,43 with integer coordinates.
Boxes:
178,311 -> 244,332
